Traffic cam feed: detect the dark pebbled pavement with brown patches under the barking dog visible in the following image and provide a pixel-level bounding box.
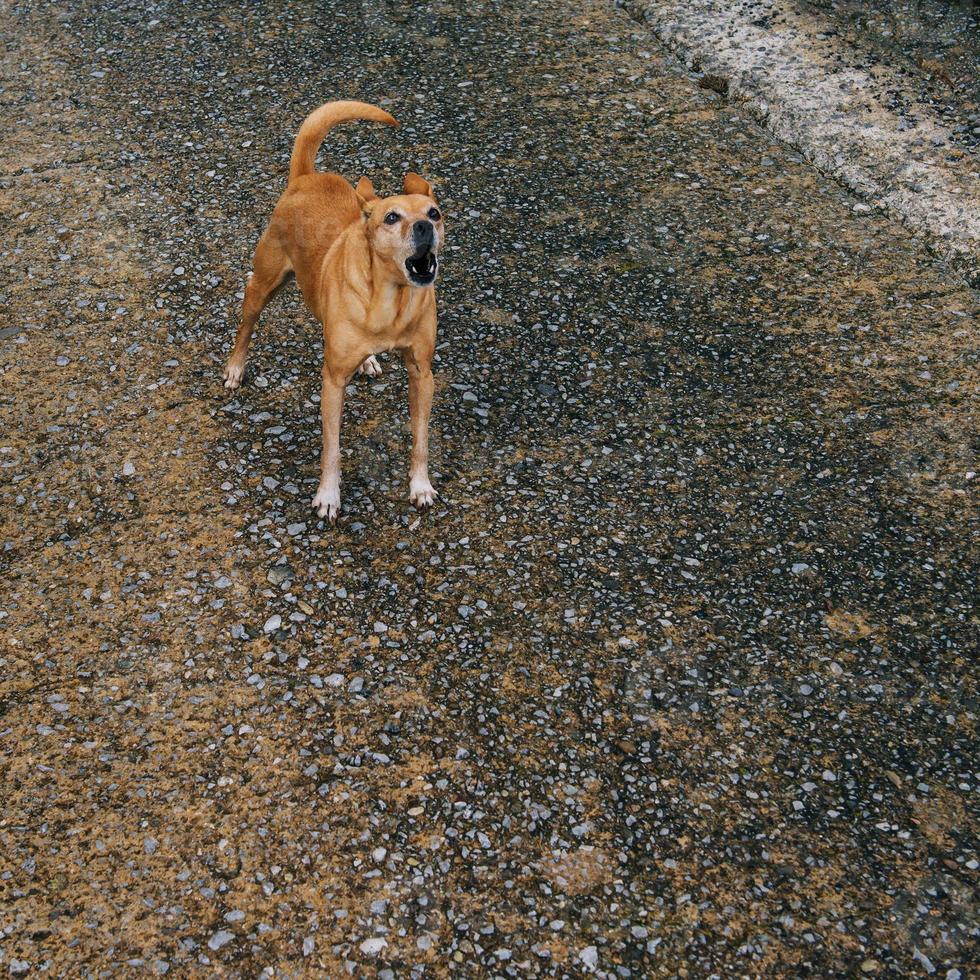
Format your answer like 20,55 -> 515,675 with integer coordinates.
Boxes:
0,0 -> 980,978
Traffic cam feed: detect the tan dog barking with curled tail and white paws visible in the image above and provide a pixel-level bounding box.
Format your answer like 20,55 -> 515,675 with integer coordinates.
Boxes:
224,102 -> 443,523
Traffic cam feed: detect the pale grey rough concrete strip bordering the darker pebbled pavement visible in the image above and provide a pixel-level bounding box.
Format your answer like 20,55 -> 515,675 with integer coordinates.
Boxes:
627,0 -> 980,286
